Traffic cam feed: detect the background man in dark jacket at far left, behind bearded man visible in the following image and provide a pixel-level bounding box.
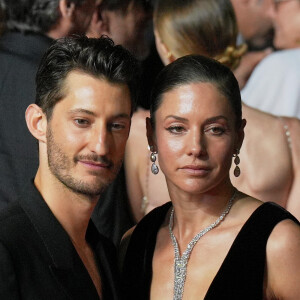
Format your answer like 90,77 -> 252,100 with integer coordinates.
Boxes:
0,0 -> 97,210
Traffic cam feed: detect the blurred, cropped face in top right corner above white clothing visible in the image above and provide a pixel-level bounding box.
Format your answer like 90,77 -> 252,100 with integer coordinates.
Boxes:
267,0 -> 300,49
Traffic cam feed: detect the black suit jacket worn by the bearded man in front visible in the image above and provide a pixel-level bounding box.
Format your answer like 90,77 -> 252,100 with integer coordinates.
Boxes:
0,183 -> 119,300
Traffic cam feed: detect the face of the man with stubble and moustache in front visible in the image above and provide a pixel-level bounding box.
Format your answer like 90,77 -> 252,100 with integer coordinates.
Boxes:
47,71 -> 131,196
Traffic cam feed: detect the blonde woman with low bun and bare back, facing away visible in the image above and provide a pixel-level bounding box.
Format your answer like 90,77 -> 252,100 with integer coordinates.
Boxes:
125,0 -> 300,221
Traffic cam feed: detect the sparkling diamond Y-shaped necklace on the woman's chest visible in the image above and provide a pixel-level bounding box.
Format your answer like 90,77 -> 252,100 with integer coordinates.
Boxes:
169,190 -> 236,300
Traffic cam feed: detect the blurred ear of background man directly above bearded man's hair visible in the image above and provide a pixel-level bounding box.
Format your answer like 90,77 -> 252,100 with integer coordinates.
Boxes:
86,4 -> 110,38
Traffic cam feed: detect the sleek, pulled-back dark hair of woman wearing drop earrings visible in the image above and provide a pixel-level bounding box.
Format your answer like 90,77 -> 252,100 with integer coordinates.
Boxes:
150,55 -> 242,128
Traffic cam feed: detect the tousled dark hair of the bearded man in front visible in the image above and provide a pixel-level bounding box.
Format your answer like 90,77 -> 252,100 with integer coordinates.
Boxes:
36,36 -> 140,120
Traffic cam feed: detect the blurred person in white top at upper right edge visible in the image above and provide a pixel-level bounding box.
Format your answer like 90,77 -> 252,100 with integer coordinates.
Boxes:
242,0 -> 300,118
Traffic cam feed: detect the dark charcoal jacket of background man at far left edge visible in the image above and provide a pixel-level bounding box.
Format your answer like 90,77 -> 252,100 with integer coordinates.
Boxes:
0,32 -> 52,210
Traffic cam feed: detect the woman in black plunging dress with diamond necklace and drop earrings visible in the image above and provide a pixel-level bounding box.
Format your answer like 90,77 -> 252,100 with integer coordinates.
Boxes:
122,55 -> 300,300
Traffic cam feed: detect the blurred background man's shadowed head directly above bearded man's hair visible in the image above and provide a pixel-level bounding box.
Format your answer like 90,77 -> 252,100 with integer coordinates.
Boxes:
87,0 -> 152,60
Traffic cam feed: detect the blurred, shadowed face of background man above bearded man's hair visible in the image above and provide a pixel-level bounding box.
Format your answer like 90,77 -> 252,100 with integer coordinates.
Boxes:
108,1 -> 151,59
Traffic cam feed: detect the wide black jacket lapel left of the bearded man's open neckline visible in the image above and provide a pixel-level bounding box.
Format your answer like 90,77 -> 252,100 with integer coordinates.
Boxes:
20,182 -> 99,300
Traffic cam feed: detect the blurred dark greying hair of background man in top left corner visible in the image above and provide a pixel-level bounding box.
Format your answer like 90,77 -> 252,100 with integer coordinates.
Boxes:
0,0 -> 85,33
